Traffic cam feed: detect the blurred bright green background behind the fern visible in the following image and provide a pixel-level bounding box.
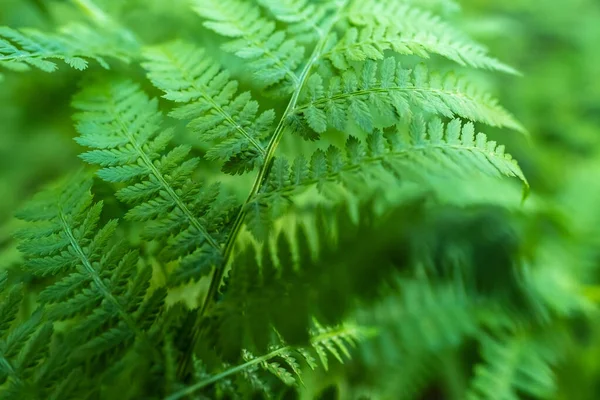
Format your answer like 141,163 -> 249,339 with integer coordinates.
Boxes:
0,0 -> 600,399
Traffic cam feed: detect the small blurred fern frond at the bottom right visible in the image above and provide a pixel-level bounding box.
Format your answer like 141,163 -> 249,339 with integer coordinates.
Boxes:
466,333 -> 557,400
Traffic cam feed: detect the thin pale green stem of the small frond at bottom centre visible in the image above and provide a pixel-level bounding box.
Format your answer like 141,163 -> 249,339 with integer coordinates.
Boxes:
164,327 -> 356,400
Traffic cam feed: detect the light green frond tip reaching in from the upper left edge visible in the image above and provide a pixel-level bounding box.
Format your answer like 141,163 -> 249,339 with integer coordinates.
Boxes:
0,24 -> 133,72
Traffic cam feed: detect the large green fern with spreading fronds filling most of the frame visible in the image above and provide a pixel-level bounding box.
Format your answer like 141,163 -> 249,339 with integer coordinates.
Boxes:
0,0 -> 593,400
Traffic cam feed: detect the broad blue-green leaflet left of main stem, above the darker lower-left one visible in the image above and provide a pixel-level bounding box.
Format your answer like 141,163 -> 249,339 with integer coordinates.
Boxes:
74,82 -> 232,283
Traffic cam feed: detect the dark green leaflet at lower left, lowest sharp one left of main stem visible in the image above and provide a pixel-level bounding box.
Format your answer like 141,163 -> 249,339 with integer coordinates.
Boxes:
14,175 -> 162,376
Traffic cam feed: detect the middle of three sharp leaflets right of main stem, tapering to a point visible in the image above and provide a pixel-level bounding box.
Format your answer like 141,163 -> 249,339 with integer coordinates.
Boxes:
294,58 -> 523,133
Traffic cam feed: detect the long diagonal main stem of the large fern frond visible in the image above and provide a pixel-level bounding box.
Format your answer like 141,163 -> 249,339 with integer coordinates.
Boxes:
178,0 -> 348,376
